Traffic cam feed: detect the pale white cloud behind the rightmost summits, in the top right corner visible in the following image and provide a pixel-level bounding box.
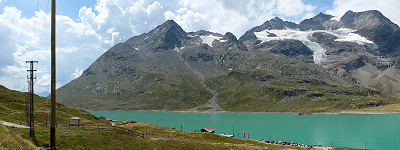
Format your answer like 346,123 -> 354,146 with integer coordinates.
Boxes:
326,0 -> 400,25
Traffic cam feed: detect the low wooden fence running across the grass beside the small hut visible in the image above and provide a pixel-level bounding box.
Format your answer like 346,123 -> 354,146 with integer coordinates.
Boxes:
45,122 -> 144,138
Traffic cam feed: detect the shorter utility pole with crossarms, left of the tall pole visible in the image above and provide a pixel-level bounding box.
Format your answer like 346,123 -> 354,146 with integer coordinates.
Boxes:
26,61 -> 38,137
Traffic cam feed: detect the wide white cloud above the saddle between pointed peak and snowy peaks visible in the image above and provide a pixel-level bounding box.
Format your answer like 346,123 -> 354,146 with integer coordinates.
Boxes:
164,0 -> 316,37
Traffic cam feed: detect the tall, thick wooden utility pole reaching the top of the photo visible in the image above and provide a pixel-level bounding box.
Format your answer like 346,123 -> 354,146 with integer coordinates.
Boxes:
50,0 -> 57,149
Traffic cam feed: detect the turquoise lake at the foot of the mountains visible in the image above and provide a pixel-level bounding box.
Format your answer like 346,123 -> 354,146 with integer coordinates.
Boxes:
89,111 -> 400,149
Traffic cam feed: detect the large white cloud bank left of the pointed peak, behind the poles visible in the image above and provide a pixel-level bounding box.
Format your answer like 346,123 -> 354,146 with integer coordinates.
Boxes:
0,0 -> 170,92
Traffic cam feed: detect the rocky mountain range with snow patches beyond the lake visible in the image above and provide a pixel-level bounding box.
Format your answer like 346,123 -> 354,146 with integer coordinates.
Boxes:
57,10 -> 400,112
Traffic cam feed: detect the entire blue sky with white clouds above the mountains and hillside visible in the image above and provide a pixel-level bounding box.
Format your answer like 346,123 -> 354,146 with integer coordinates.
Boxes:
0,0 -> 400,93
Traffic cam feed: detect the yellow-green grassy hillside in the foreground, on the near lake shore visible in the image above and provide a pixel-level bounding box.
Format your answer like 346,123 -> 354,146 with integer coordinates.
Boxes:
0,86 -> 360,149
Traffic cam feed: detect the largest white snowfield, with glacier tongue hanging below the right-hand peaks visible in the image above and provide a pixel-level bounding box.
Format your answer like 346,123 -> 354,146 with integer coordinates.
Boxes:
254,28 -> 376,65
